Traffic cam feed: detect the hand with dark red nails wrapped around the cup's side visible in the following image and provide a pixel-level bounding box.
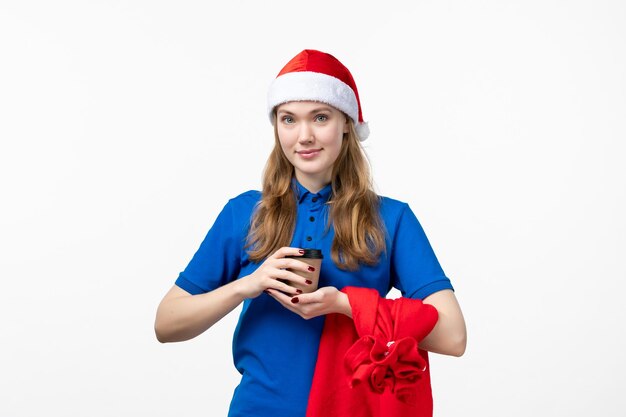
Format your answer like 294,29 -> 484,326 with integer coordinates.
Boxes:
238,247 -> 312,299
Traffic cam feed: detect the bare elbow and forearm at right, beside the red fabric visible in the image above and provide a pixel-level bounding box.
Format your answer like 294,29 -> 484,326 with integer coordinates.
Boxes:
419,290 -> 467,356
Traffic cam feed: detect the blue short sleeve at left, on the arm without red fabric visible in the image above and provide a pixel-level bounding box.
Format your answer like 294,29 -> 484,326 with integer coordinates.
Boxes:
176,200 -> 245,295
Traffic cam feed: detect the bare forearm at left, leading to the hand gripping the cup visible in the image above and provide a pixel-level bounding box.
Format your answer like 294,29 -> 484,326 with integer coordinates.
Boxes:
154,280 -> 244,343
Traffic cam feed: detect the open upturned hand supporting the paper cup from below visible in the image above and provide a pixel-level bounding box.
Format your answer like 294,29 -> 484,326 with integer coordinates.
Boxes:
265,287 -> 352,320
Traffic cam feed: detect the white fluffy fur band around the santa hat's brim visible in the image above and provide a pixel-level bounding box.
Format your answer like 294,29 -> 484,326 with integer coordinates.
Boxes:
267,71 -> 364,127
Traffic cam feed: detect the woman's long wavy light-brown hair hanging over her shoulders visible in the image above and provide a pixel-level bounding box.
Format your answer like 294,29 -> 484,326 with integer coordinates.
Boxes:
246,118 -> 385,270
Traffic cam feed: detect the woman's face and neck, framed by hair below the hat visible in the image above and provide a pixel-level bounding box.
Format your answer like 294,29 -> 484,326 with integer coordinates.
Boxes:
276,101 -> 348,192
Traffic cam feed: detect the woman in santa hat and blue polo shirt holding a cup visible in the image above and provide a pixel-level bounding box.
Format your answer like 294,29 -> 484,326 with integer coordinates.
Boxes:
155,50 -> 466,417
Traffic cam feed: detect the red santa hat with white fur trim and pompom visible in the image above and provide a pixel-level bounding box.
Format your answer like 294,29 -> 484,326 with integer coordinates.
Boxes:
267,49 -> 369,140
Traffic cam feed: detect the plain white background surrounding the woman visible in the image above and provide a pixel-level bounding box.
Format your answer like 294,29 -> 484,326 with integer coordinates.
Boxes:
0,0 -> 626,417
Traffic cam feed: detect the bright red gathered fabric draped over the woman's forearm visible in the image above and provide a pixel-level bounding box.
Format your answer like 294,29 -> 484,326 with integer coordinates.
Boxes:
306,287 -> 438,417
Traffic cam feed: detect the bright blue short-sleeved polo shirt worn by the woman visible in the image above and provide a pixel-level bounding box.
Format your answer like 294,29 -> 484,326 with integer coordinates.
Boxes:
176,181 -> 453,417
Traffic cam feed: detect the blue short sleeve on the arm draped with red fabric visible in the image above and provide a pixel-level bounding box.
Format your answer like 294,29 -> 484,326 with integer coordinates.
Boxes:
390,204 -> 454,300
